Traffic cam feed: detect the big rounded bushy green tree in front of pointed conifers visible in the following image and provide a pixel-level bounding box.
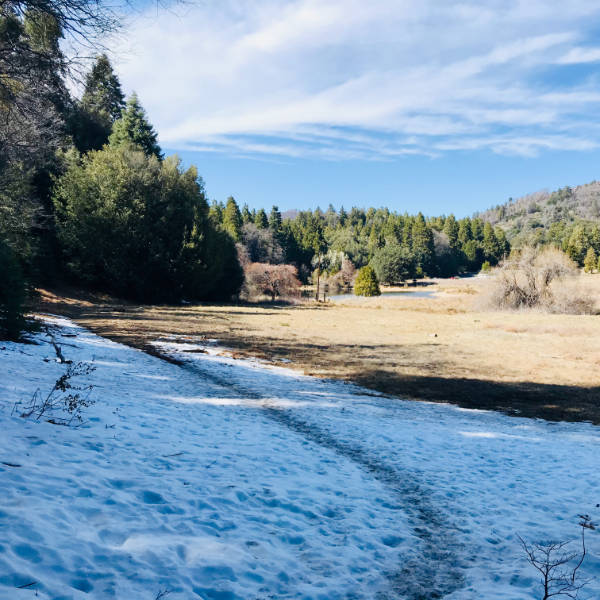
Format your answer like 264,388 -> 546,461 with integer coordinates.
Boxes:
54,143 -> 241,301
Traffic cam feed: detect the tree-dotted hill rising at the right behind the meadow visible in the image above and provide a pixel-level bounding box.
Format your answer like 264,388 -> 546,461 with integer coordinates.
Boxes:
477,181 -> 600,250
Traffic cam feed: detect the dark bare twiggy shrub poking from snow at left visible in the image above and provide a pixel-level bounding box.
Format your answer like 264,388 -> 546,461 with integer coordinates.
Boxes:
13,362 -> 96,425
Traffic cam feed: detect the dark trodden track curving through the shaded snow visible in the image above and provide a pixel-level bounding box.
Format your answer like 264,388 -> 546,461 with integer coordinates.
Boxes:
173,355 -> 464,600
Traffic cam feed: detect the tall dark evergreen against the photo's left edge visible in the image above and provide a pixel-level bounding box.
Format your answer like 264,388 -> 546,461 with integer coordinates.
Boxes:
0,2 -> 71,281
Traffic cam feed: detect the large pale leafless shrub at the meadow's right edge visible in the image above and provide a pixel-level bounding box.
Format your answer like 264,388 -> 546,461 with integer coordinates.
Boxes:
485,247 -> 594,314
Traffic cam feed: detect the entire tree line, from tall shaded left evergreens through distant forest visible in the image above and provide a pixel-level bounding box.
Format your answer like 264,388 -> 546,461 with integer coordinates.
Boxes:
0,0 -> 508,335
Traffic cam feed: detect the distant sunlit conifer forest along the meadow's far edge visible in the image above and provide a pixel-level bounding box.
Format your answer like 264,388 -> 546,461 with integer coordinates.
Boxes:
210,198 -> 510,284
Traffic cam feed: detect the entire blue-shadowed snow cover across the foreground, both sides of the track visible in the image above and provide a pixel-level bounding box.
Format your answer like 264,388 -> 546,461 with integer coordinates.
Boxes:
0,319 -> 600,600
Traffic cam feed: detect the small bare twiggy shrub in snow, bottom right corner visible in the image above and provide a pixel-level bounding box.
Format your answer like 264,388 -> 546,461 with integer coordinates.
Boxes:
518,515 -> 596,600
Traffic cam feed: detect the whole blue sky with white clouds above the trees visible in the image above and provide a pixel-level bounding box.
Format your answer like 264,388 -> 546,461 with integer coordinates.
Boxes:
113,0 -> 600,215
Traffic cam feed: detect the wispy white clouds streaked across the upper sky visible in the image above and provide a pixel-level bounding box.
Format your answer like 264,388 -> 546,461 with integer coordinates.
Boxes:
117,0 -> 600,160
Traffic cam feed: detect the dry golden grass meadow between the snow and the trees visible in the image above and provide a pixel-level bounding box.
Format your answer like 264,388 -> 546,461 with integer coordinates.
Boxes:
39,275 -> 600,424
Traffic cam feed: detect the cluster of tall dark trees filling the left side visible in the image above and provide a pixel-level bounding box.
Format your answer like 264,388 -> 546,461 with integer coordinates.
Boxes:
0,0 -> 243,337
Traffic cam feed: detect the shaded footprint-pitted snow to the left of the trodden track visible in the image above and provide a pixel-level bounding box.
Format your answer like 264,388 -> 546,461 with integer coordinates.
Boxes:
0,327 -> 418,599
